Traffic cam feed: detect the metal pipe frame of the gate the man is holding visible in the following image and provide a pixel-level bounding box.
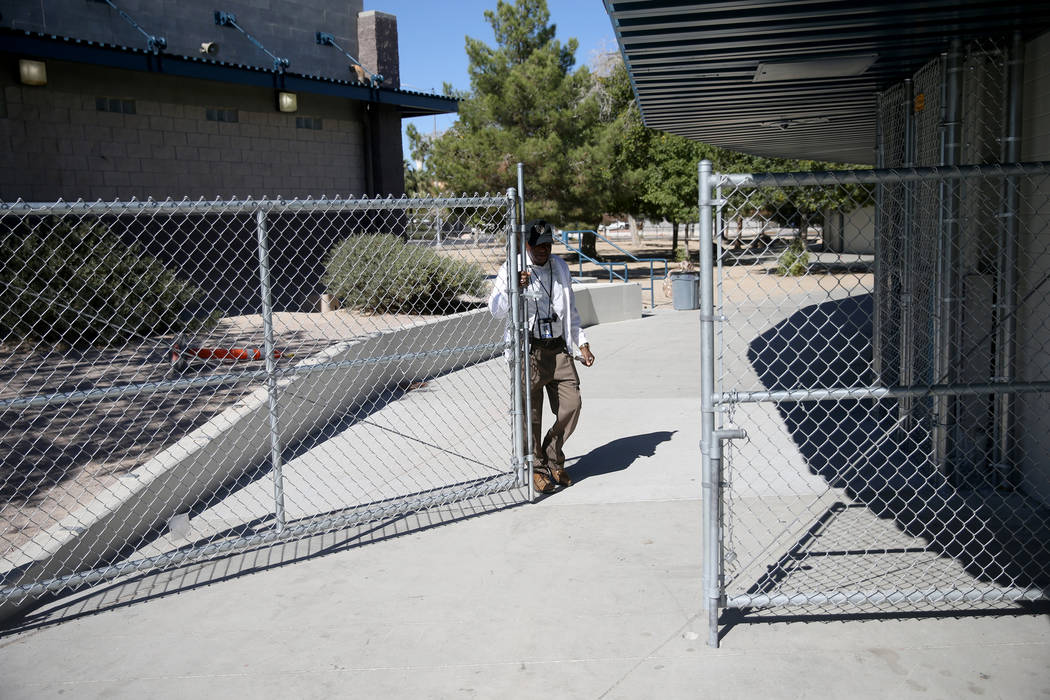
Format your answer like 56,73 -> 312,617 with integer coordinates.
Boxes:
0,189 -> 531,618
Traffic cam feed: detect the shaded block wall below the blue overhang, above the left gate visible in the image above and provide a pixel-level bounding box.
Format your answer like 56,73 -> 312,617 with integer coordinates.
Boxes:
0,61 -> 367,201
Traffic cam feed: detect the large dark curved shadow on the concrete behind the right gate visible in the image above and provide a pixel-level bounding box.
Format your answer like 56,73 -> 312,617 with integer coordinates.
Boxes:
748,294 -> 1050,600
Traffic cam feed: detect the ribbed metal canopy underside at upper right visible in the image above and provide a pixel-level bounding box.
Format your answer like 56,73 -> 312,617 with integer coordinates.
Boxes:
605,0 -> 1050,164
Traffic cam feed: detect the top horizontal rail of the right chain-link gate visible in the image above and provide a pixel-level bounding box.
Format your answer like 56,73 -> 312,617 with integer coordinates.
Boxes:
714,162 -> 1050,187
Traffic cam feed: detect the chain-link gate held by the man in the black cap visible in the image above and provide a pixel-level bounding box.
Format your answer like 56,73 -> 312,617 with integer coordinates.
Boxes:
0,190 -> 525,617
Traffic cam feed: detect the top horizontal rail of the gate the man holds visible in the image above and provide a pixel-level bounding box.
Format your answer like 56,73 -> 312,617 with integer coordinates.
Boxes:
0,194 -> 508,216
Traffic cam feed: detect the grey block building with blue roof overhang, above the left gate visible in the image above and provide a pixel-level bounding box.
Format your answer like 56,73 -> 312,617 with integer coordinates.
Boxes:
0,0 -> 456,201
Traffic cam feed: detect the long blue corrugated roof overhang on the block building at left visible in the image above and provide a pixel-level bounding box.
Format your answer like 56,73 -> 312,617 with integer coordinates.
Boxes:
0,28 -> 458,116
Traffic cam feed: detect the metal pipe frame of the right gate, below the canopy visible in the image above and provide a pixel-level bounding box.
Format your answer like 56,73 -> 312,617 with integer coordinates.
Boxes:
698,161 -> 1050,648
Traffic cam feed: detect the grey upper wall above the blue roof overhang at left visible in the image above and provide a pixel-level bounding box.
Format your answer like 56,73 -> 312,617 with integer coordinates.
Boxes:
0,0 -> 363,80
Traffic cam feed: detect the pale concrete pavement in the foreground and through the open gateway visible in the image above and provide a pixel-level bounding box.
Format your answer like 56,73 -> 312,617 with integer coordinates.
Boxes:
0,312 -> 1050,700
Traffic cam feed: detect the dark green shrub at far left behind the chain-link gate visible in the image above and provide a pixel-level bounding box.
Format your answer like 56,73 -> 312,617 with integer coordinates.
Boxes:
0,218 -> 215,346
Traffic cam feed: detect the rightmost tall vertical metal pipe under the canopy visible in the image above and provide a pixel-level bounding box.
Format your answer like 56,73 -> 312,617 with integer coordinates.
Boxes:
992,31 -> 1025,486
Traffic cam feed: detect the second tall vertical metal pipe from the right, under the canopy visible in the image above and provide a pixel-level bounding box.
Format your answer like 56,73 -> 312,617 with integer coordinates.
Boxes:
933,39 -> 963,474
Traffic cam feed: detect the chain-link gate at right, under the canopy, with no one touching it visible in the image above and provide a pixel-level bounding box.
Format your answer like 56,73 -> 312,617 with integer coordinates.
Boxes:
700,162 -> 1050,645
